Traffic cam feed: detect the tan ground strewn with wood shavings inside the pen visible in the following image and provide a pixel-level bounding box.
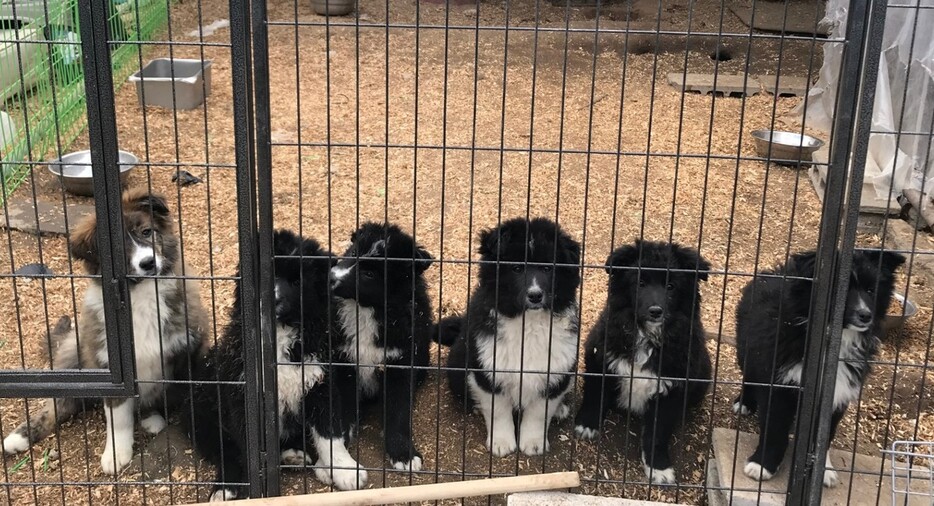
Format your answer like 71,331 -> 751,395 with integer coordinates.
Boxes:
0,0 -> 934,504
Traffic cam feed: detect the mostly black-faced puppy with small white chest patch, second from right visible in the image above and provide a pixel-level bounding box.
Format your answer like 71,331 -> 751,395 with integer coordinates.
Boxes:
574,240 -> 711,484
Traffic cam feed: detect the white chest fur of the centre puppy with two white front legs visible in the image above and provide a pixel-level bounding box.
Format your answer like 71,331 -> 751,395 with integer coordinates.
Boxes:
477,307 -> 577,407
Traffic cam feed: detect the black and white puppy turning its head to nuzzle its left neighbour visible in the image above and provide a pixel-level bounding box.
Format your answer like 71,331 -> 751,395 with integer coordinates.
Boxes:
331,223 -> 434,471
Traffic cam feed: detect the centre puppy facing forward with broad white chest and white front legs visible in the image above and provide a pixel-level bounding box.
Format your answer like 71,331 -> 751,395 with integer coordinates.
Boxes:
439,218 -> 580,457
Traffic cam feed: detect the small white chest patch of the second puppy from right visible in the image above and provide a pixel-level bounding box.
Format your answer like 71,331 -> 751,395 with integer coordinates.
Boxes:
608,334 -> 672,414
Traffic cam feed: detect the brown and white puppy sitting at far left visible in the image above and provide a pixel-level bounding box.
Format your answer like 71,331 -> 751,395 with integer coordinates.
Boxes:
3,189 -> 208,474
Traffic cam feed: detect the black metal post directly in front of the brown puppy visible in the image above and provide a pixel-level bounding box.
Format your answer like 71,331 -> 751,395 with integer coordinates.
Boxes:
78,0 -> 136,395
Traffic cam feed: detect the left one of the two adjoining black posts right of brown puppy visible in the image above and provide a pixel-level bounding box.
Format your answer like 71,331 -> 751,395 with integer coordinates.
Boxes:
230,0 -> 265,497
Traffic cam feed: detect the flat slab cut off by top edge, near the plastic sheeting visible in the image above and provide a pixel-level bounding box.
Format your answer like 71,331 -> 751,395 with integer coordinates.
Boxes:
730,1 -> 830,37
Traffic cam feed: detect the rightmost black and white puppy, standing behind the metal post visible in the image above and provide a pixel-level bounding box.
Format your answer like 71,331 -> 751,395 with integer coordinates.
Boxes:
733,251 -> 905,487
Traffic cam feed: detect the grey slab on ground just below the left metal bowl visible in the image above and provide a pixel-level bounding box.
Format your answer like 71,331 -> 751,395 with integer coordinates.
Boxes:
0,195 -> 94,235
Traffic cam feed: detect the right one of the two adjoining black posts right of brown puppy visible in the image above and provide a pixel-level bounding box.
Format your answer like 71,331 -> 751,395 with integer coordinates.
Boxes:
252,1 -> 279,496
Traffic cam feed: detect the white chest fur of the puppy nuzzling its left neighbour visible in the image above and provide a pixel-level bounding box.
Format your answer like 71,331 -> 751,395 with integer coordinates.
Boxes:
337,299 -> 402,397
